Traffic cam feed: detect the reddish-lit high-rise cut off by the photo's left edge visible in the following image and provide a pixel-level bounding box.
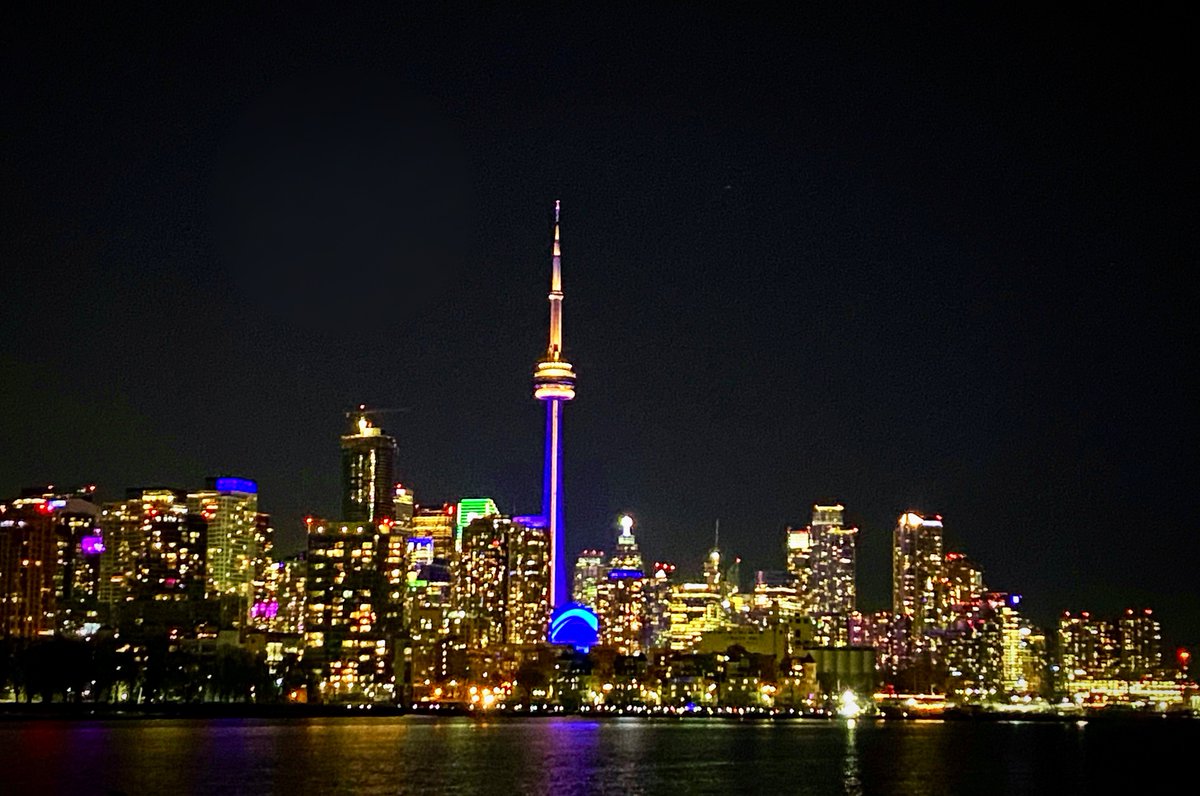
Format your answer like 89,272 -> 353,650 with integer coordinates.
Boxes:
0,497 -> 56,639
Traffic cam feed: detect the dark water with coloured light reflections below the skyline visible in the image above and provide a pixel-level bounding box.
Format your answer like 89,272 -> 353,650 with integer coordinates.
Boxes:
0,717 -> 1200,796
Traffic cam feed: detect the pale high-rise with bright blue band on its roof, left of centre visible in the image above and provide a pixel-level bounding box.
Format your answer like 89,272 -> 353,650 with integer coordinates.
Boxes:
187,477 -> 260,627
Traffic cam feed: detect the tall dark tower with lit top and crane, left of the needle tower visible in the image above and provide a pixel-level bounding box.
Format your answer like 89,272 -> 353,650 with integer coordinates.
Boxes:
342,406 -> 396,522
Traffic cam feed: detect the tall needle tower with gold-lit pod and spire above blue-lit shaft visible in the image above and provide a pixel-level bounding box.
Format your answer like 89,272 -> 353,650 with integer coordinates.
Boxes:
533,202 -> 575,606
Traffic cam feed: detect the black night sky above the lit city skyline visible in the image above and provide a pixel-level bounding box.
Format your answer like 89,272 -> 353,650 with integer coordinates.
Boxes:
0,4 -> 1200,641
